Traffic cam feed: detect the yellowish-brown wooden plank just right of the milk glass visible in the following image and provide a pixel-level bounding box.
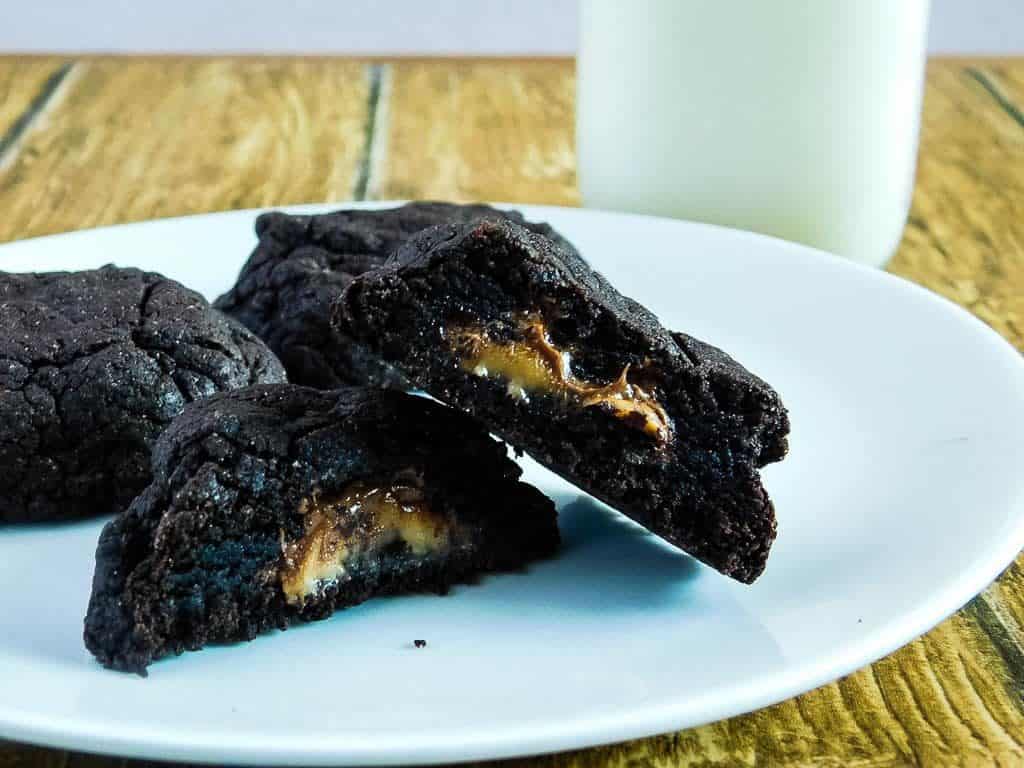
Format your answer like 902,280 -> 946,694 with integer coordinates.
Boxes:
890,62 -> 1024,349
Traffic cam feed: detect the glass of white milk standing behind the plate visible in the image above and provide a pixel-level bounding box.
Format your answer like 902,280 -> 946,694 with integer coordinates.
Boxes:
577,0 -> 929,265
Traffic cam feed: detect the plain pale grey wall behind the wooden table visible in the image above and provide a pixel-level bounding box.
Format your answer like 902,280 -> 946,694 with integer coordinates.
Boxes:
0,0 -> 1024,55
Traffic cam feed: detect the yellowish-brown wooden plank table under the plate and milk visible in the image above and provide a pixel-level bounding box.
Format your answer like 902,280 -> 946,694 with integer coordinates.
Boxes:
0,57 -> 1024,767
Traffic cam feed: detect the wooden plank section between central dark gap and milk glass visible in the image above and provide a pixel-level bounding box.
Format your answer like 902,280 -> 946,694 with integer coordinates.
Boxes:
370,60 -> 579,205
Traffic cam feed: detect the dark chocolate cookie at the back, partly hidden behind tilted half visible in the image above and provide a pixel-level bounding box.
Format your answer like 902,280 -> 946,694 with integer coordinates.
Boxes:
215,203 -> 572,389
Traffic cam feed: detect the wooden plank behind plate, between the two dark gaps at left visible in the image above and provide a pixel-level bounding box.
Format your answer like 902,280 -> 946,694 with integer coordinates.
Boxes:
0,58 -> 369,242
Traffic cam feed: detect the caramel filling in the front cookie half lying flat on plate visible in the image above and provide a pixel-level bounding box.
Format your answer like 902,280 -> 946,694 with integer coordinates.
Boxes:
281,480 -> 455,604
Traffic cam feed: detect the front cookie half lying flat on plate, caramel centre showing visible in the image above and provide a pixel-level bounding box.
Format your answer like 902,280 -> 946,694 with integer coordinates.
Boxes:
85,385 -> 558,674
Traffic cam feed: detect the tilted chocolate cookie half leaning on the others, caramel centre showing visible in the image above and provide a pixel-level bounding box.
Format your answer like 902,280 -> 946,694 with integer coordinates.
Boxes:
334,219 -> 790,582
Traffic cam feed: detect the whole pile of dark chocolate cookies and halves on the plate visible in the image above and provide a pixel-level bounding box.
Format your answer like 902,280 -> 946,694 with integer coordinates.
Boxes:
0,203 -> 788,674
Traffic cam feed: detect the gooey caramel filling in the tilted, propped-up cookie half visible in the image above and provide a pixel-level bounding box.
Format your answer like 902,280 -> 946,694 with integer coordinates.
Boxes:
454,316 -> 671,441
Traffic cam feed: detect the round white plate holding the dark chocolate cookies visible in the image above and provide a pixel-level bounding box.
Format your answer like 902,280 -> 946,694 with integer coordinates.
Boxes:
0,206 -> 1024,764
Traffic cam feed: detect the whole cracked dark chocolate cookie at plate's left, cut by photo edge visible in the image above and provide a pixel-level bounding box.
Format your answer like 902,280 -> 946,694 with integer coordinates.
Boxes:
0,266 -> 285,523
